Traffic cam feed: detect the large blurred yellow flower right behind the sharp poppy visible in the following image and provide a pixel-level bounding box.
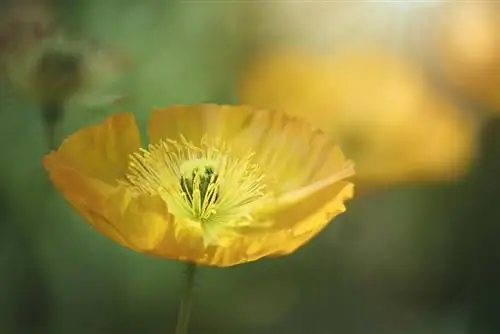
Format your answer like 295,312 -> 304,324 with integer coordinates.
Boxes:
240,50 -> 476,184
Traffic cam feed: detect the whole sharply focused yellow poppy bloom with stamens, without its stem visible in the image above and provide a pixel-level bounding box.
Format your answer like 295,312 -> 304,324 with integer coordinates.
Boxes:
44,105 -> 354,266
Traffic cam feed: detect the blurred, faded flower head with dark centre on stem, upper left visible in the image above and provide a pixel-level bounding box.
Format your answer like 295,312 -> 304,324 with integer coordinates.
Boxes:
6,29 -> 128,147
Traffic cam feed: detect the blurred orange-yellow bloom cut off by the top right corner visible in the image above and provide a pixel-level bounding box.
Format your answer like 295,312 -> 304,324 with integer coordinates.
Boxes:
431,1 -> 500,111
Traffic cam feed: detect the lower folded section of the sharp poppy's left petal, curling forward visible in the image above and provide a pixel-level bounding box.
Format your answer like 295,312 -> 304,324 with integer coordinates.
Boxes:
44,153 -> 170,251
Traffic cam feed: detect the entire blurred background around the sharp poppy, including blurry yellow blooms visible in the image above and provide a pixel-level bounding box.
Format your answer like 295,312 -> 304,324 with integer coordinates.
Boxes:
0,0 -> 500,334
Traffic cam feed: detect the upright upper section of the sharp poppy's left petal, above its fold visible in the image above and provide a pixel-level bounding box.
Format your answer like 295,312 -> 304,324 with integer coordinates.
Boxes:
49,113 -> 140,184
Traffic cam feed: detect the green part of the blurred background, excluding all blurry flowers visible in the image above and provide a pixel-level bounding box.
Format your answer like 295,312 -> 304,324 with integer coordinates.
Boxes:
0,0 -> 500,334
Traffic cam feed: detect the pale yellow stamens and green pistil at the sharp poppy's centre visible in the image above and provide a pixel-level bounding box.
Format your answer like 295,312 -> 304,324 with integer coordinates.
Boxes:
120,137 -> 269,228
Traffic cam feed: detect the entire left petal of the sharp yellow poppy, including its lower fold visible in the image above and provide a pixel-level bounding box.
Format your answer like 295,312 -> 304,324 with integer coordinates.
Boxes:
44,113 -> 168,251
